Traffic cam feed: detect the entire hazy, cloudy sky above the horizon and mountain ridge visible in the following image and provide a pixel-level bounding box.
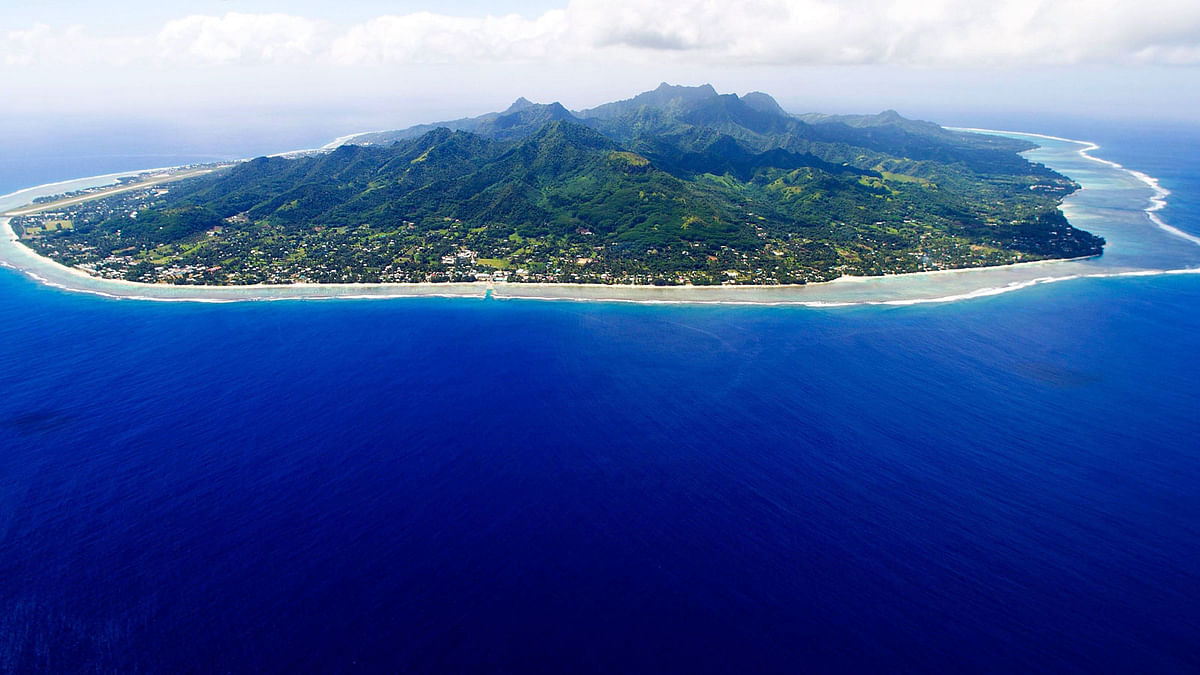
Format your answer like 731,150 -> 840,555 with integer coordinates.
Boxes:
0,0 -> 1200,132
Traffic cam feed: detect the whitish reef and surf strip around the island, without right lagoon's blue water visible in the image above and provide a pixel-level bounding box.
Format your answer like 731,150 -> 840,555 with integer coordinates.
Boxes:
0,129 -> 1200,307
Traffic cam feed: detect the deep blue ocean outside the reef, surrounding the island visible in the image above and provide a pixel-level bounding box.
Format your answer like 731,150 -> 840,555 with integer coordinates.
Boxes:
0,114 -> 1200,674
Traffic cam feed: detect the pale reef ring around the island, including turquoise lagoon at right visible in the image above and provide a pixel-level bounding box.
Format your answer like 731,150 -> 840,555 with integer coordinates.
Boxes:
0,129 -> 1200,307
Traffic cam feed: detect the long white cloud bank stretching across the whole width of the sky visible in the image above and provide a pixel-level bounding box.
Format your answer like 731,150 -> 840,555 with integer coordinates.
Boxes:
7,0 -> 1200,68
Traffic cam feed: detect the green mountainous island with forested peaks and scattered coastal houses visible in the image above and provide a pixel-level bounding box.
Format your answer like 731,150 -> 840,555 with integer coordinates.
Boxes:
7,84 -> 1105,286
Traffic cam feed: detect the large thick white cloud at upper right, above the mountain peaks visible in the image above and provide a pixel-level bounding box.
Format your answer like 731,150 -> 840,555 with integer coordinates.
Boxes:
568,0 -> 1200,66
